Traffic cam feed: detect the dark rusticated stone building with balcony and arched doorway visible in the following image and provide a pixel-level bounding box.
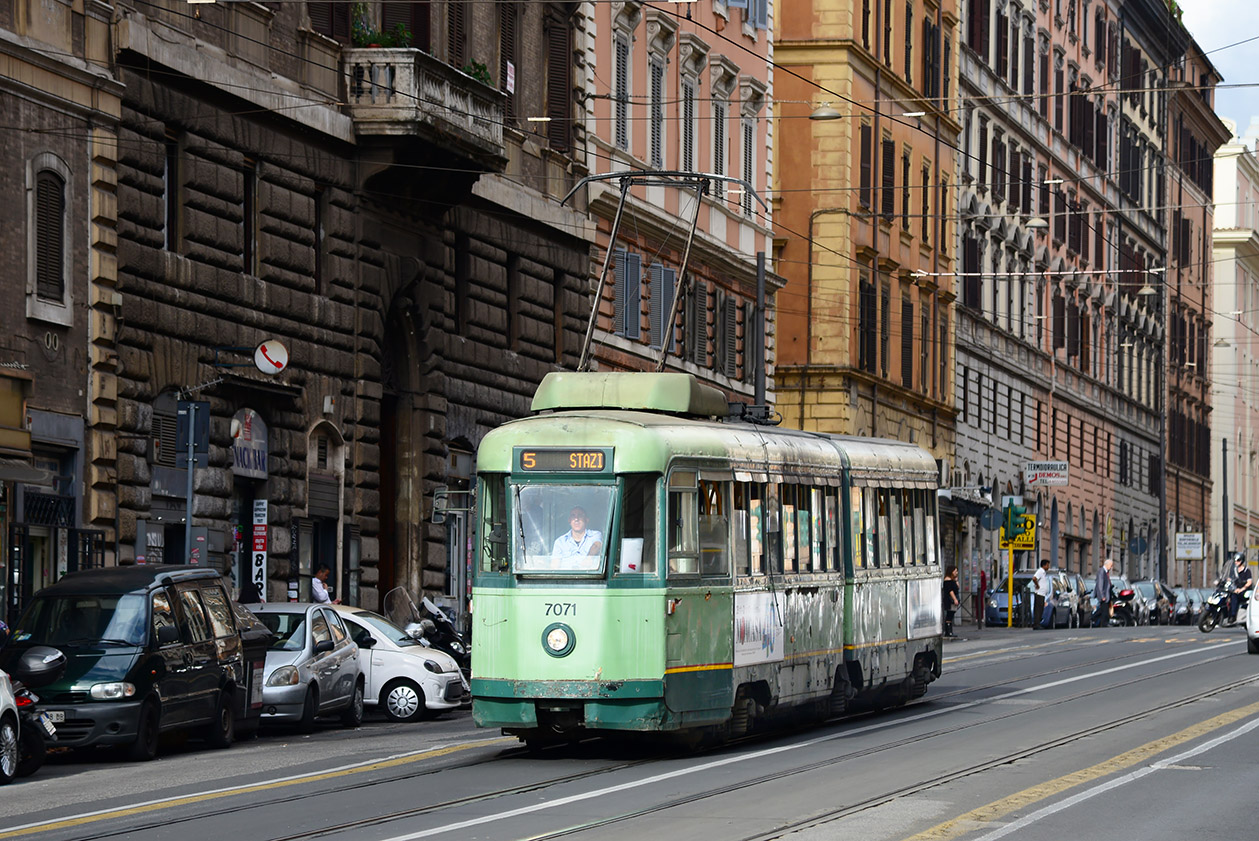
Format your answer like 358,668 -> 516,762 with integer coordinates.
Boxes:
3,1 -> 593,612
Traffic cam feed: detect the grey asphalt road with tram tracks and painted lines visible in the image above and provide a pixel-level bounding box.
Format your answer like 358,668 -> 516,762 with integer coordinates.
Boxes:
0,627 -> 1259,841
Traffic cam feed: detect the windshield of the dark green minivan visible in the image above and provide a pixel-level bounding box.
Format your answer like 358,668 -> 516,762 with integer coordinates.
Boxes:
13,593 -> 149,646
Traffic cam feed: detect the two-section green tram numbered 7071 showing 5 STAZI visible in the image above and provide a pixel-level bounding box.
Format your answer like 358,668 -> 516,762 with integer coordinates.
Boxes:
472,373 -> 942,743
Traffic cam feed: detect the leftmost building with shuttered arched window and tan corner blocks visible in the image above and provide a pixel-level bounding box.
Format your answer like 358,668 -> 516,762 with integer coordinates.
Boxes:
0,0 -> 122,619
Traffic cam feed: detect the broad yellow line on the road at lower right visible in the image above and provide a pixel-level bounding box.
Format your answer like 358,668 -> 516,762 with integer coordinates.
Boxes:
905,704 -> 1259,841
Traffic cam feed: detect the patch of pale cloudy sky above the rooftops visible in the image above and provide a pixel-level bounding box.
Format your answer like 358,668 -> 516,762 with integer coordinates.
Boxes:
1178,0 -> 1259,135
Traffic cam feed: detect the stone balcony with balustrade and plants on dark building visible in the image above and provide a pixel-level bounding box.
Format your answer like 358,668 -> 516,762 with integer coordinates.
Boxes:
341,48 -> 506,171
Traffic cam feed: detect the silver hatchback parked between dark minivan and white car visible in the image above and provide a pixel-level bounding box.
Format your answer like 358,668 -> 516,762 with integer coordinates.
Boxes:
249,602 -> 365,733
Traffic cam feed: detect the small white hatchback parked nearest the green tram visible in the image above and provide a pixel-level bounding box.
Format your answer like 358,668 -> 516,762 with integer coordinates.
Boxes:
332,604 -> 468,721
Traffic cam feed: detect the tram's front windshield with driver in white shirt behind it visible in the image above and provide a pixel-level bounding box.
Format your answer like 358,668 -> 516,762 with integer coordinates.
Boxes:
512,485 -> 616,573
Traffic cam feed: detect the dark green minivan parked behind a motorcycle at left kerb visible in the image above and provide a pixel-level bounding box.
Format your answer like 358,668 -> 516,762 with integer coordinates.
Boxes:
0,564 -> 262,760
